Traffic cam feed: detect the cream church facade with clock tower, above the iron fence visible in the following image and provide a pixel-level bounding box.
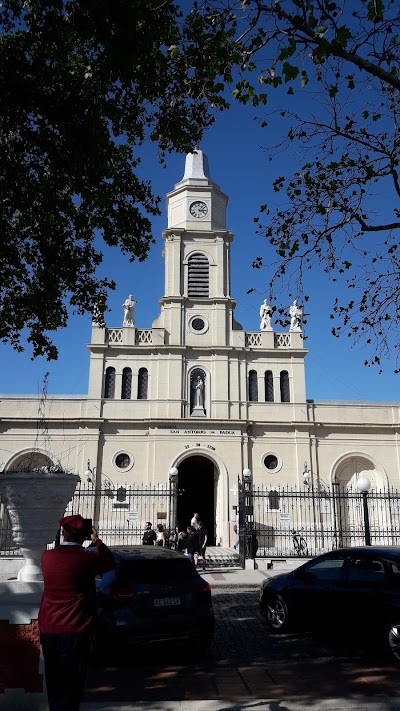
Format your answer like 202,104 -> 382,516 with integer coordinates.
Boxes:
0,151 -> 400,546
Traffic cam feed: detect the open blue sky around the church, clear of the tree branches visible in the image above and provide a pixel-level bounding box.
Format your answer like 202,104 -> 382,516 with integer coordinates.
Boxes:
0,95 -> 400,401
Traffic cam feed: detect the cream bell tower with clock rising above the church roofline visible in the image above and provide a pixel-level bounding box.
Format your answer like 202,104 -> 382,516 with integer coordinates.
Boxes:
153,150 -> 240,347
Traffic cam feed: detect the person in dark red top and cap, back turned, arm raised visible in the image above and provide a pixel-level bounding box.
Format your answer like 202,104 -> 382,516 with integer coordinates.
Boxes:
39,514 -> 115,711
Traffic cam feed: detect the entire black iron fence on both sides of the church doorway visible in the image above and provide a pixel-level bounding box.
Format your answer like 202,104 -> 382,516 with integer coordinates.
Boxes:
0,478 -> 400,566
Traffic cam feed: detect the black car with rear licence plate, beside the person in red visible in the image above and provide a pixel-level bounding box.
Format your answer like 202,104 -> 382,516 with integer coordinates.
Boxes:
96,546 -> 214,652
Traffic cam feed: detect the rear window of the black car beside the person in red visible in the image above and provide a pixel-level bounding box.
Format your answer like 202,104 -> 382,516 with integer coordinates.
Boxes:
117,558 -> 197,583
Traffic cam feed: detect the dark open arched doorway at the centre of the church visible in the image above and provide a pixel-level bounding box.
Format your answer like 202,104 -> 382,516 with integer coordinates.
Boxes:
177,456 -> 215,546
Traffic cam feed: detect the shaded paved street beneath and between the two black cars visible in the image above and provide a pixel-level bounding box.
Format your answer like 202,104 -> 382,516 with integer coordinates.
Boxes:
83,586 -> 400,711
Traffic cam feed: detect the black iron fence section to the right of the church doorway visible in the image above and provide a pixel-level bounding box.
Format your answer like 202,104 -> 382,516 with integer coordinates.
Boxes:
250,485 -> 400,558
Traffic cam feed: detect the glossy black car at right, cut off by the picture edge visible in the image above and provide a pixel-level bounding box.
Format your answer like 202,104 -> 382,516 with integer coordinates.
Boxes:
260,546 -> 400,660
